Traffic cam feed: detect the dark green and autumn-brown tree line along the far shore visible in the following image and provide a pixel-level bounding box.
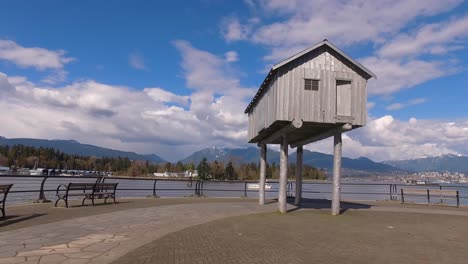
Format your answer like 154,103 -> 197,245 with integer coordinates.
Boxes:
0,145 -> 326,180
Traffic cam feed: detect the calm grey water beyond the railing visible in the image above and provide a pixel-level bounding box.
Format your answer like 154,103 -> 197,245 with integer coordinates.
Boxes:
0,175 -> 468,205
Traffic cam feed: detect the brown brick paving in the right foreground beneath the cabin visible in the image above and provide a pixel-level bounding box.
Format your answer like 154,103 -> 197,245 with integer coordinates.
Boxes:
114,207 -> 468,264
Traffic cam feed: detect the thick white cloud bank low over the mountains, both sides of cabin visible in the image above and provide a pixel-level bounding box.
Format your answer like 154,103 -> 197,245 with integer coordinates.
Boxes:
0,66 -> 468,161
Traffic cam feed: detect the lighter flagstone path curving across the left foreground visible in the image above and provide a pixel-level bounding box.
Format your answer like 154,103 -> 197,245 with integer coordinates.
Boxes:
0,202 -> 276,264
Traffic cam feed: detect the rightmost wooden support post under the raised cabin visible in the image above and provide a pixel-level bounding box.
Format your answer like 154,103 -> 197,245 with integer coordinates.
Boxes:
332,133 -> 343,215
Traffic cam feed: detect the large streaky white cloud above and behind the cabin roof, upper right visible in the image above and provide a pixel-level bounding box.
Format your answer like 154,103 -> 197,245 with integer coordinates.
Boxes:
221,0 -> 468,96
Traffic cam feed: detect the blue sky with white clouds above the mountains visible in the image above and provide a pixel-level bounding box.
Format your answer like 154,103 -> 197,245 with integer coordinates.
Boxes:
0,0 -> 468,160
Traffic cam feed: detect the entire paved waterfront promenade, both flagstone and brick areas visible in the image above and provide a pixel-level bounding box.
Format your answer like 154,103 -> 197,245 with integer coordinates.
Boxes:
0,198 -> 468,263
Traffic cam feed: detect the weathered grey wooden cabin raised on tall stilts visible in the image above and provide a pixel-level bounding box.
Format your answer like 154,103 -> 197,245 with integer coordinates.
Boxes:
245,39 -> 376,215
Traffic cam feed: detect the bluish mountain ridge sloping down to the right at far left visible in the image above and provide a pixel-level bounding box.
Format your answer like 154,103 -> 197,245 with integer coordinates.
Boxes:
0,137 -> 166,163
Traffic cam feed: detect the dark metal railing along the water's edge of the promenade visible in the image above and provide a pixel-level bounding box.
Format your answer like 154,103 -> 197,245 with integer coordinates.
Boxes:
0,175 -> 468,203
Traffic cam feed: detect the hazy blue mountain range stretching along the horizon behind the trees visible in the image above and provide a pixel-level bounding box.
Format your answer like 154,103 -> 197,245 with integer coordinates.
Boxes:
0,137 -> 468,175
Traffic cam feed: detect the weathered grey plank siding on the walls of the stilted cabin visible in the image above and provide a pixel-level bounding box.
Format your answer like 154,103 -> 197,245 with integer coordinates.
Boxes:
249,47 -> 367,140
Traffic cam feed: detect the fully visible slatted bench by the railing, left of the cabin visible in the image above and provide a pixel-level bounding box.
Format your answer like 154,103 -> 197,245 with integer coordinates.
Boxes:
55,182 -> 118,208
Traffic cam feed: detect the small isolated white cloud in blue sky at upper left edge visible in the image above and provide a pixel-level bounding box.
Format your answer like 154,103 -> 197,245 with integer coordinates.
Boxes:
0,39 -> 75,70
